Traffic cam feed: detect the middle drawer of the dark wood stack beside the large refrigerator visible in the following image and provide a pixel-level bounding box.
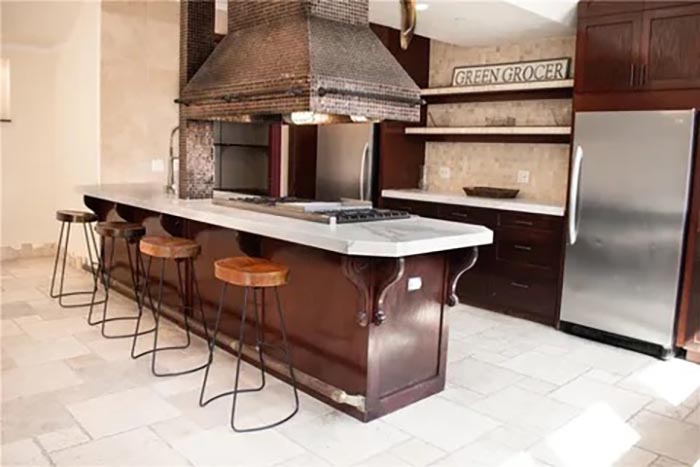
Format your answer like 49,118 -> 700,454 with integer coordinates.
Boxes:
496,228 -> 561,268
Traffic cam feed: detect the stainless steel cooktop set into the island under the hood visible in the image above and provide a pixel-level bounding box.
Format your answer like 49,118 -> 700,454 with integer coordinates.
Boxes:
213,192 -> 411,225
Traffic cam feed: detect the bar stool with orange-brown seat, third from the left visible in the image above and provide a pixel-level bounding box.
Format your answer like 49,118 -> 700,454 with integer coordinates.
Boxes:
131,237 -> 209,376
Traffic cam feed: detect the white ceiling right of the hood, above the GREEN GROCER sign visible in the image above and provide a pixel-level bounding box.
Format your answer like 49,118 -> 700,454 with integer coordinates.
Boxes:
369,0 -> 577,46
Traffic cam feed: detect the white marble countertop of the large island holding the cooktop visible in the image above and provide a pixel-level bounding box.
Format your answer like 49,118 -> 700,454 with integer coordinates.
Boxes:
77,184 -> 493,258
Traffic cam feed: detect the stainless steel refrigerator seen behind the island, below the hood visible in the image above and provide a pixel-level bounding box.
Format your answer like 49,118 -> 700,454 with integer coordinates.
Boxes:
316,123 -> 378,201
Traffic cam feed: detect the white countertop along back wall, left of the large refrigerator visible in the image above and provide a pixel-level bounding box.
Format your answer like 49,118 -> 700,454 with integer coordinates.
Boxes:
382,189 -> 564,217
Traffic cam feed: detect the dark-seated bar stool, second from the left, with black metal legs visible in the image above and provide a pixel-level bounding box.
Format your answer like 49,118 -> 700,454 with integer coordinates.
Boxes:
87,222 -> 153,339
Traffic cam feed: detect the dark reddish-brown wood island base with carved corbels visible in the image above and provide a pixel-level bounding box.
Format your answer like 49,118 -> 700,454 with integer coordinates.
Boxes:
85,196 -> 477,422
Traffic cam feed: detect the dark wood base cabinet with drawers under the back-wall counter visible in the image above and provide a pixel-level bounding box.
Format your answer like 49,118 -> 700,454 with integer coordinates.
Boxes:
381,198 -> 564,326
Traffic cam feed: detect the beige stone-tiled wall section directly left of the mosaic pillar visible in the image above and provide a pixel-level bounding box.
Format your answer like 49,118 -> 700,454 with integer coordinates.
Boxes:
100,1 -> 180,184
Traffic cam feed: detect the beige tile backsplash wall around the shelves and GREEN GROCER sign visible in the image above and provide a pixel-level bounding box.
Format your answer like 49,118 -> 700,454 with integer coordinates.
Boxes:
426,36 -> 575,205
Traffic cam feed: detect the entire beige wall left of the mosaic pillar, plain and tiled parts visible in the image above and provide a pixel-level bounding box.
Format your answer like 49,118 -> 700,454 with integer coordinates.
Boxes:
0,0 -> 179,259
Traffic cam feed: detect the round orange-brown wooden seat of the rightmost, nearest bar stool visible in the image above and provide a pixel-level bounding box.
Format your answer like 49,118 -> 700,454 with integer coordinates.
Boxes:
214,256 -> 289,287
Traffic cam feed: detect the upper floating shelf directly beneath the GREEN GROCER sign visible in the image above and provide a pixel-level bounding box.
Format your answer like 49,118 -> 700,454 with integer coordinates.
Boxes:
421,79 -> 574,104
